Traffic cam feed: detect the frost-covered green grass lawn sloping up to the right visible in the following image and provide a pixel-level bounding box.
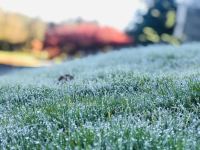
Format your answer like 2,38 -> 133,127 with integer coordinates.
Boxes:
0,43 -> 200,149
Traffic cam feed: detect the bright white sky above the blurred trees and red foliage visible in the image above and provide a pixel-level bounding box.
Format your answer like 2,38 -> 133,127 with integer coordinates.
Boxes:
0,0 -> 145,30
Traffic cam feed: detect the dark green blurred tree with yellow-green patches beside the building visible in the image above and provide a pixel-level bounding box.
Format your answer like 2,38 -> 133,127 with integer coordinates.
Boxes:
127,0 -> 178,45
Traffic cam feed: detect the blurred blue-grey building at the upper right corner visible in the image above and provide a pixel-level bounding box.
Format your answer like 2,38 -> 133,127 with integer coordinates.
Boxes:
174,0 -> 200,41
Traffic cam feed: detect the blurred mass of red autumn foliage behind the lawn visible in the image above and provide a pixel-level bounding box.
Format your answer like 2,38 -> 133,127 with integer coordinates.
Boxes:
44,23 -> 133,57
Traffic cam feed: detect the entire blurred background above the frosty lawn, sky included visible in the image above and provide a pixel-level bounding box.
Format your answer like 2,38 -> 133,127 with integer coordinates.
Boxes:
0,0 -> 200,75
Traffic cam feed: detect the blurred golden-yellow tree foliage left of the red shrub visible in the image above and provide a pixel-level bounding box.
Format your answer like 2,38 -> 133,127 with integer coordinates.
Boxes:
0,10 -> 46,50
